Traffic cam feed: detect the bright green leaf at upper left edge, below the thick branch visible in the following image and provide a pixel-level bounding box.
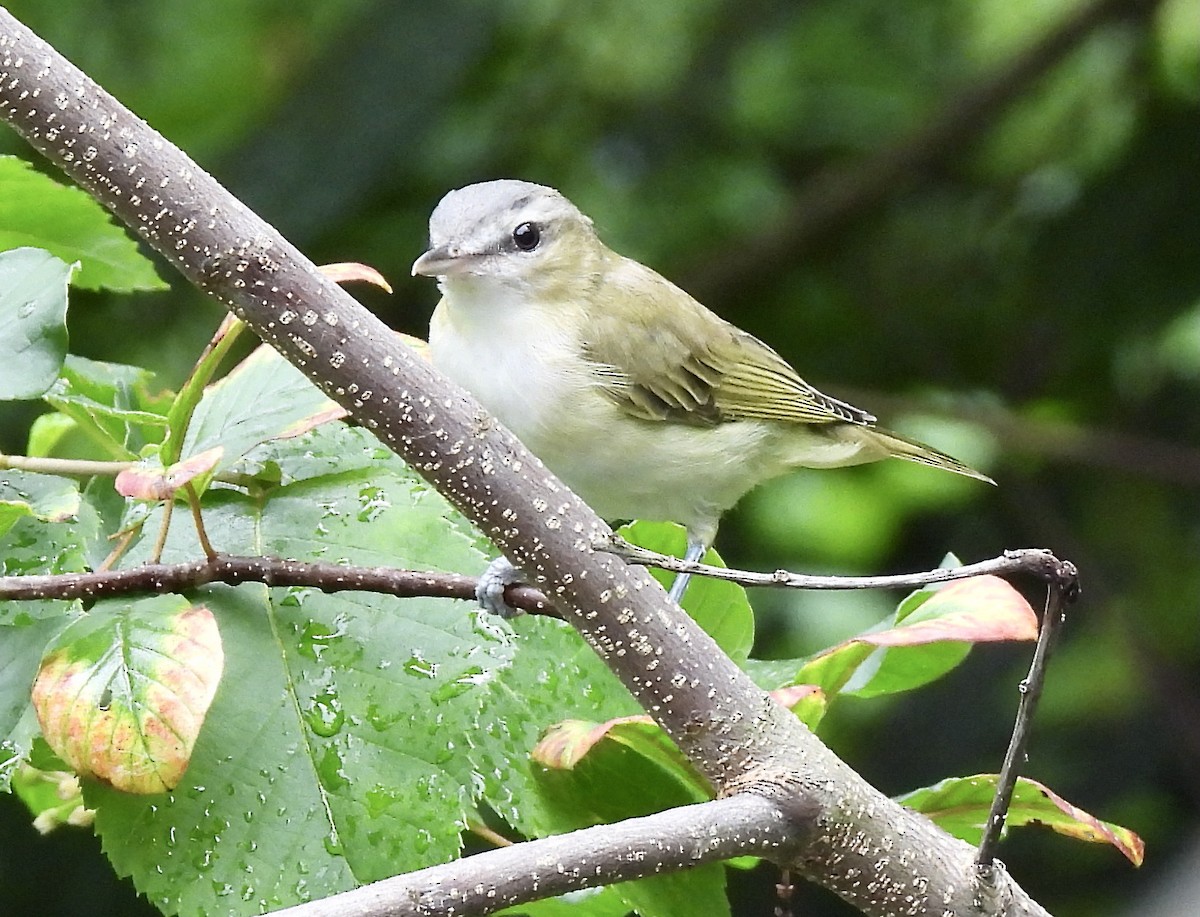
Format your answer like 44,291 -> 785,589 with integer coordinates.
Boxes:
0,156 -> 167,293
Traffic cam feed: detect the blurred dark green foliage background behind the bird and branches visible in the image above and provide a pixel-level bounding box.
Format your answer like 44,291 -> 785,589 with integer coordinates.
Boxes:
0,0 -> 1200,917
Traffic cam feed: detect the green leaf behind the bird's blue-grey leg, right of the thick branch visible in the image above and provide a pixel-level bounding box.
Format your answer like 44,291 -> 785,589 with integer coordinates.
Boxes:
618,522 -> 754,665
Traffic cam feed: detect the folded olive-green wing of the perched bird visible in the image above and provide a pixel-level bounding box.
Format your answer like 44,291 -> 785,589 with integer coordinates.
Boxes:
583,259 -> 875,425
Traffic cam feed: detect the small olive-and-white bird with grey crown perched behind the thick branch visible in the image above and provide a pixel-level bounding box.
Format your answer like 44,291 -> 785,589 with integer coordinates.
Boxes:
413,180 -> 991,605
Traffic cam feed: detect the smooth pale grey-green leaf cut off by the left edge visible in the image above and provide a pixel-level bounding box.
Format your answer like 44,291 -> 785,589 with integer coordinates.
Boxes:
0,244 -> 73,401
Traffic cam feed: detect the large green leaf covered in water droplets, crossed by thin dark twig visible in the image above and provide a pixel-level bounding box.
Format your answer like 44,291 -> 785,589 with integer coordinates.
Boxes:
85,424 -> 518,915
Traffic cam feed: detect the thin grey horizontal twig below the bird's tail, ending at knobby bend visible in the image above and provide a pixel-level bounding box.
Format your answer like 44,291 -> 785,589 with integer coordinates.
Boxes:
595,535 -> 1079,603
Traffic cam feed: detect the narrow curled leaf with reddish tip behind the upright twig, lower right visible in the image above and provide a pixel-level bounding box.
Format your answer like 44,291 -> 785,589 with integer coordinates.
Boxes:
896,774 -> 1145,865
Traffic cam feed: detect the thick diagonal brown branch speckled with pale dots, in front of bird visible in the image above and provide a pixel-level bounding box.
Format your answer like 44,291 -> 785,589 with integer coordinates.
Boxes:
0,11 -> 1044,915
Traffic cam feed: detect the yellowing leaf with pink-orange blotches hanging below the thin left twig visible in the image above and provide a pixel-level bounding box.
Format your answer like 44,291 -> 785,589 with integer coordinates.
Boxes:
32,595 -> 224,793
